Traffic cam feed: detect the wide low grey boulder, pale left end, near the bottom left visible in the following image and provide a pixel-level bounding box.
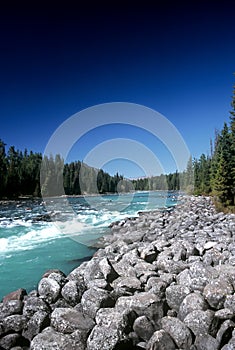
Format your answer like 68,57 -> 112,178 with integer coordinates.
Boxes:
51,308 -> 94,334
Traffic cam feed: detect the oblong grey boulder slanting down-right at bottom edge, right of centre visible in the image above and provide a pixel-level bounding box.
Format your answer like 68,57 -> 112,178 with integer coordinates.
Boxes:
161,316 -> 193,350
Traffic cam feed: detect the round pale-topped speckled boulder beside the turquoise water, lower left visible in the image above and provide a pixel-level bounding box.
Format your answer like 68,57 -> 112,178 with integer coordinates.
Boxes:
38,277 -> 61,303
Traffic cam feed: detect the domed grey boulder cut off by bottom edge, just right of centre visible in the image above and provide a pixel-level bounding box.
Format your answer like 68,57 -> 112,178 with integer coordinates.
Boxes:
146,329 -> 176,350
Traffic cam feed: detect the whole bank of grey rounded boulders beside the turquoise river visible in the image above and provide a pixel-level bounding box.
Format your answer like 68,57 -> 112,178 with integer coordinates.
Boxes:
0,197 -> 235,350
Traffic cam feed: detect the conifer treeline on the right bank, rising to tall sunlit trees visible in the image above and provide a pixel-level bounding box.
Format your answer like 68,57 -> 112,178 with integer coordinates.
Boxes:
134,79 -> 235,207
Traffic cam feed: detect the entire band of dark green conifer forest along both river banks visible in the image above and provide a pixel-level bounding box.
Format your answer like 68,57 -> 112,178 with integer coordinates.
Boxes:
0,80 -> 235,207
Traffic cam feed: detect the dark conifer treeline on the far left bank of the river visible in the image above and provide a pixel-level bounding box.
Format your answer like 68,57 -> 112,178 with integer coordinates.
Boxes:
0,144 -> 132,198
